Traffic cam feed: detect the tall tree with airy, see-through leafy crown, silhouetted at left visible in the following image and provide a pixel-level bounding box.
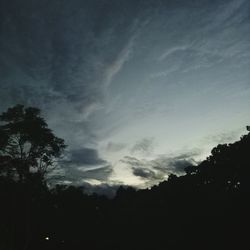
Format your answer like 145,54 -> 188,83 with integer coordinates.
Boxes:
0,105 -> 66,181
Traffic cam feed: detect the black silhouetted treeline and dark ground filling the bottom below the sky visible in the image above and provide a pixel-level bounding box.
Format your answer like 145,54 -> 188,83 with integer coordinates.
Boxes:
0,106 -> 250,250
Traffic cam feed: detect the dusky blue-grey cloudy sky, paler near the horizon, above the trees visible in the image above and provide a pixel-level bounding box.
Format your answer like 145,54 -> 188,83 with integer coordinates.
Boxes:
0,0 -> 250,188
